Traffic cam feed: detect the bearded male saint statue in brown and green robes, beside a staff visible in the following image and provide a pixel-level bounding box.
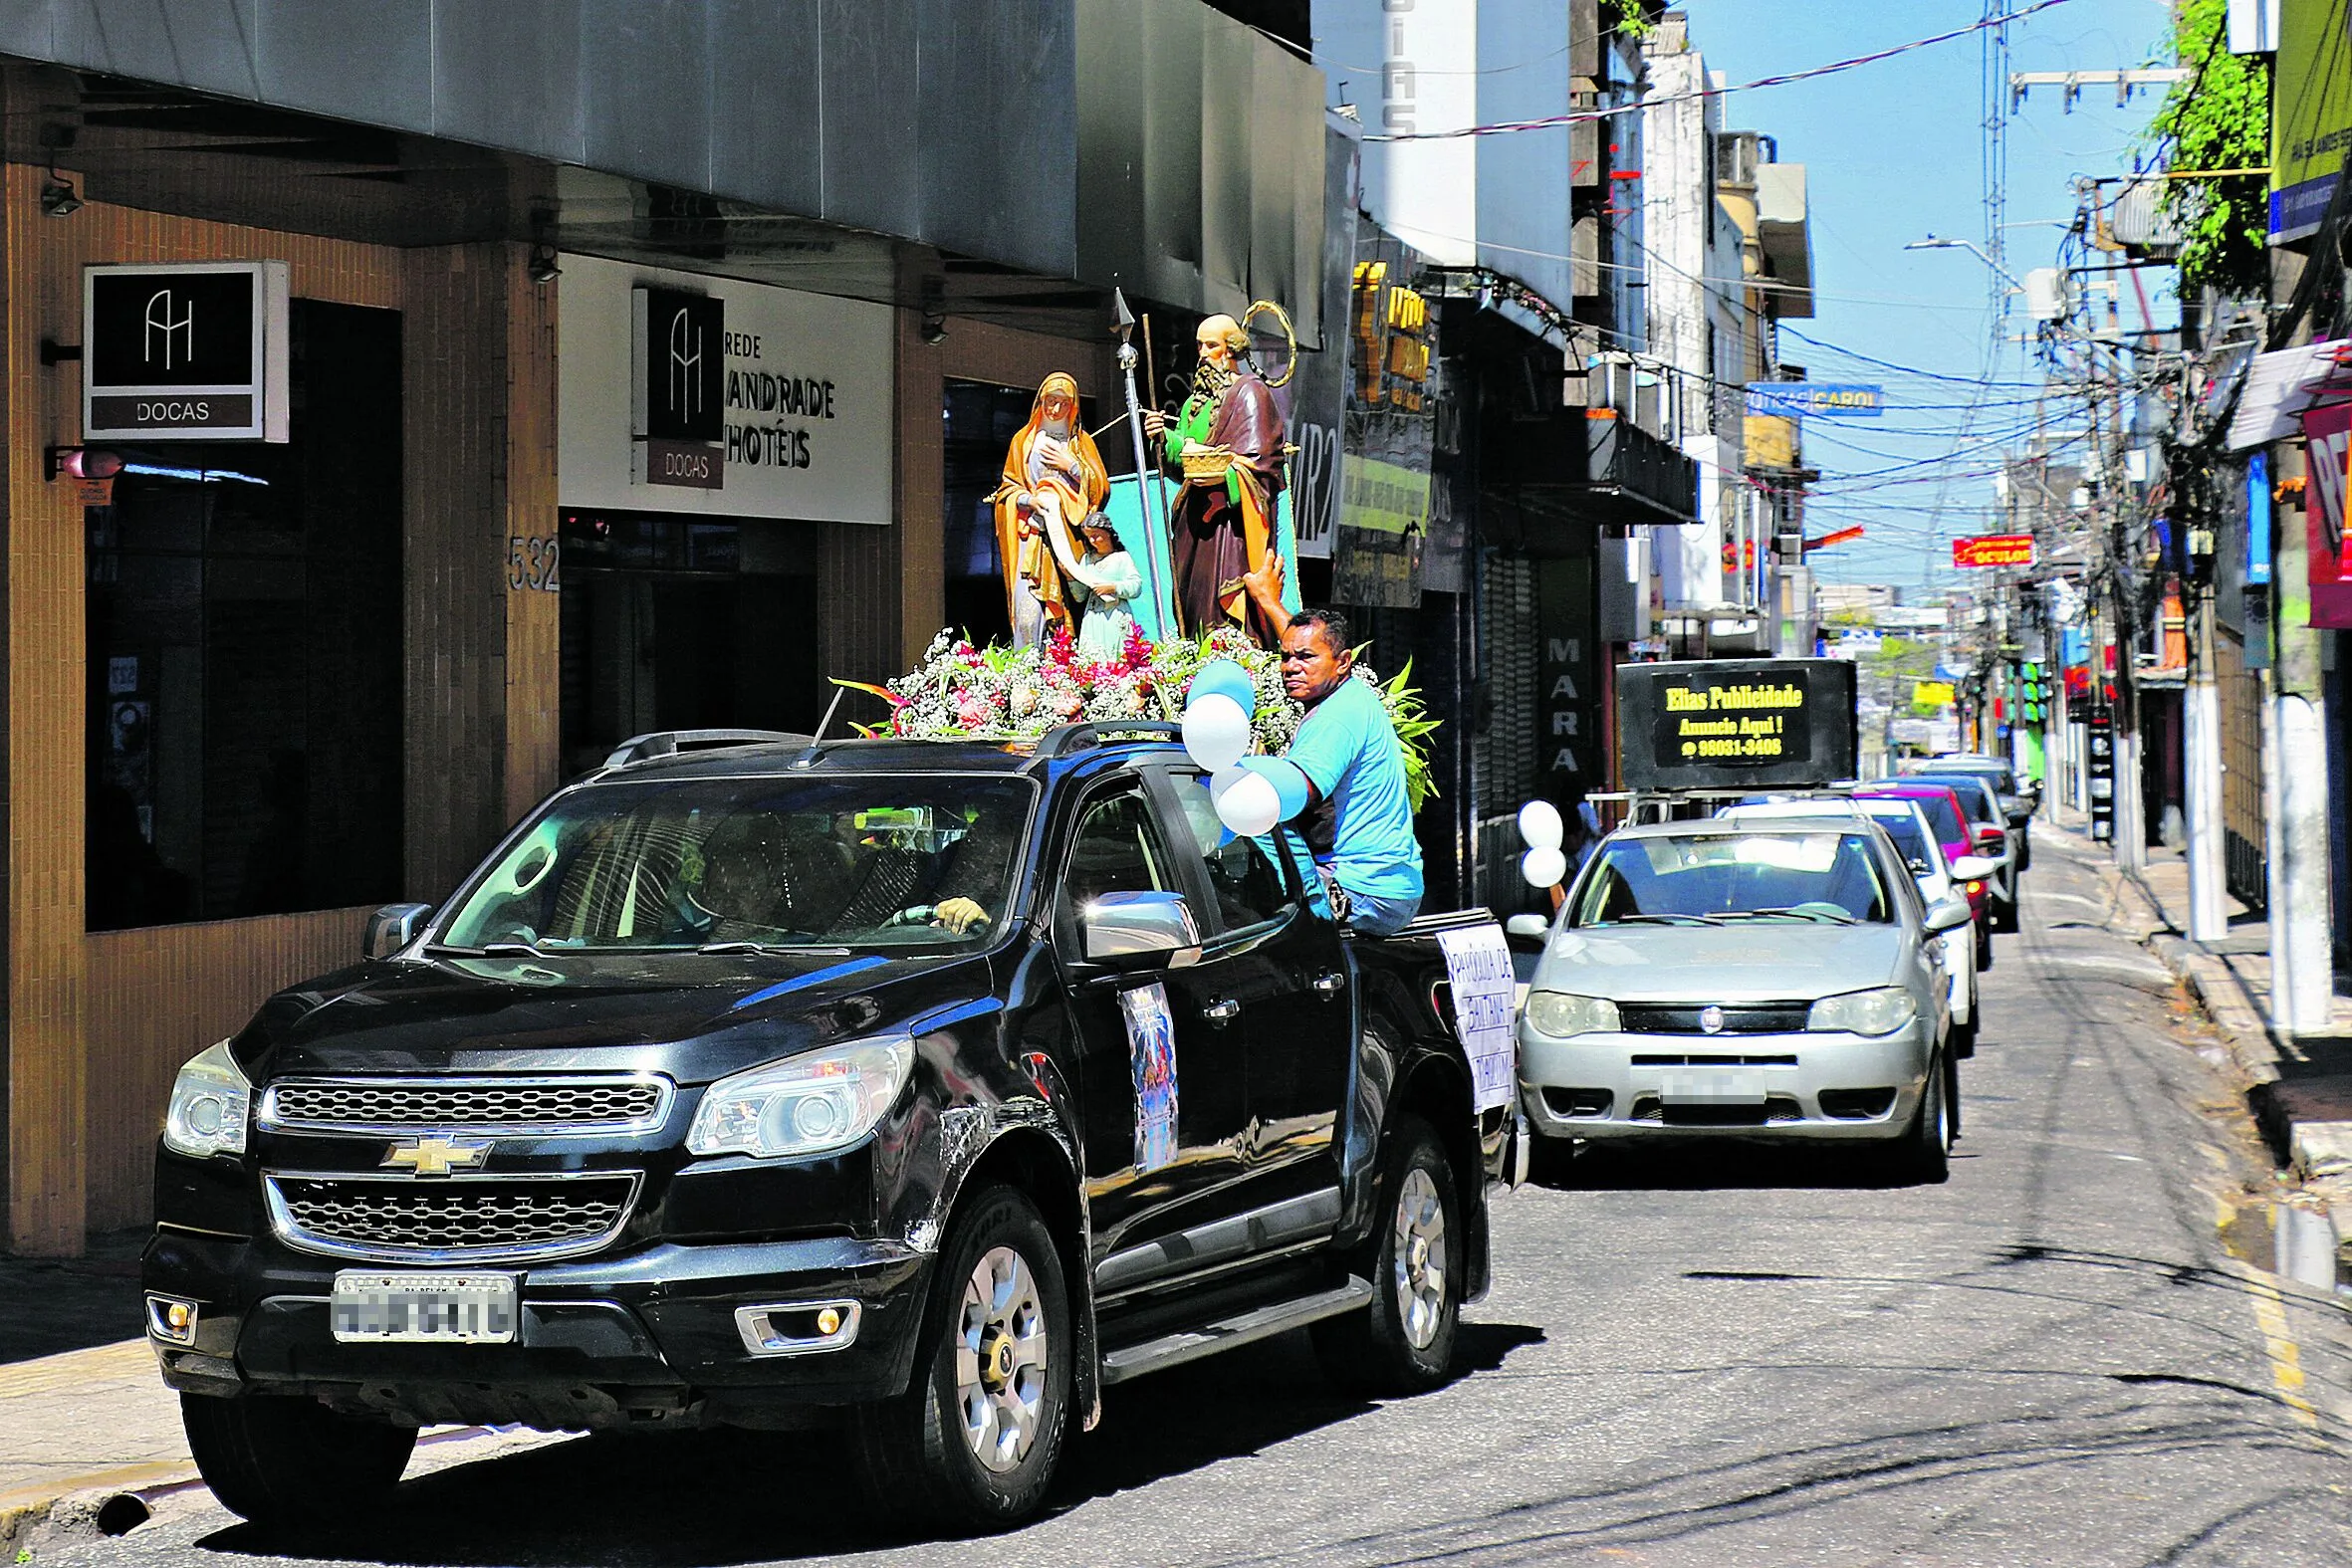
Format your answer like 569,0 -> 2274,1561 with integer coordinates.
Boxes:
1143,315 -> 1287,649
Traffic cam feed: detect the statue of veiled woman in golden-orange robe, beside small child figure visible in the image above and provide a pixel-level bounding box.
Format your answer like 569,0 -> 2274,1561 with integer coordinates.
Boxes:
990,371 -> 1110,649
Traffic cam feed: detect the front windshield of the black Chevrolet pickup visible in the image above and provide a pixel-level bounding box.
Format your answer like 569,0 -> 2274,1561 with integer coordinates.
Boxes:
435,774 -> 1035,952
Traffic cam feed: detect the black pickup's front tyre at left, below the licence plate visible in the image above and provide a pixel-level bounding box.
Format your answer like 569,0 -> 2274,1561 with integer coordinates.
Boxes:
179,1394 -> 416,1523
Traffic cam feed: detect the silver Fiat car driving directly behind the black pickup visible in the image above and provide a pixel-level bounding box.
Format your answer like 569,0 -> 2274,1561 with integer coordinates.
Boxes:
1520,815 -> 1969,1180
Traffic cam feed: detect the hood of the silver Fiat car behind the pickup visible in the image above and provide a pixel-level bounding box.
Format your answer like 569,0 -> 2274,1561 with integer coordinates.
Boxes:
1533,919 -> 1903,1002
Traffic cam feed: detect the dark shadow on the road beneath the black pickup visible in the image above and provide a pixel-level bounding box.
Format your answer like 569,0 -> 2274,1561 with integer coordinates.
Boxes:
197,1323 -> 1542,1568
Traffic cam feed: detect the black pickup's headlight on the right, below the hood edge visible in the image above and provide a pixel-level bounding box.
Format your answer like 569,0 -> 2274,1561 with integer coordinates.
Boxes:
687,1034 -> 915,1159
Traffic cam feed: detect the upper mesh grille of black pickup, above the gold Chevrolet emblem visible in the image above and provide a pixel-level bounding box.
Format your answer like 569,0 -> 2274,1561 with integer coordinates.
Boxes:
261,1076 -> 670,1133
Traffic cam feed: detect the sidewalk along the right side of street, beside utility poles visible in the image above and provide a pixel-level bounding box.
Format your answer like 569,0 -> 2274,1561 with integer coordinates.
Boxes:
2107,827 -> 2352,1232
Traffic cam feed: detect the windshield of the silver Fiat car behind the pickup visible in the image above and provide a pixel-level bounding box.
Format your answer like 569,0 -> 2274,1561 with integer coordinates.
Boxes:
1568,827 -> 1893,926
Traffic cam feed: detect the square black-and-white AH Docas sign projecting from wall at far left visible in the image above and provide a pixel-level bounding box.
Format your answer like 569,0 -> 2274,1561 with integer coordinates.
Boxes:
83,261 -> 287,442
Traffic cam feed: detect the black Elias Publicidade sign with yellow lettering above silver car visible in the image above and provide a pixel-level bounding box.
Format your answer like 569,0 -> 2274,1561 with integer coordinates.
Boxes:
1618,658 -> 1860,789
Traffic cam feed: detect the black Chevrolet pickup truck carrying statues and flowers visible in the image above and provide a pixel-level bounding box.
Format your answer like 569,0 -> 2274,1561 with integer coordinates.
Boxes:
143,727 -> 1527,1528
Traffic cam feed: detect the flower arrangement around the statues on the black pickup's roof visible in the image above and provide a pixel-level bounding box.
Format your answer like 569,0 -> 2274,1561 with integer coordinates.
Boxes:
835,625 -> 1437,811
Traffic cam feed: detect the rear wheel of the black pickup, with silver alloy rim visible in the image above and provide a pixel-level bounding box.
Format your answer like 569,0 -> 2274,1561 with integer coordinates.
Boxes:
1312,1117 -> 1468,1394
